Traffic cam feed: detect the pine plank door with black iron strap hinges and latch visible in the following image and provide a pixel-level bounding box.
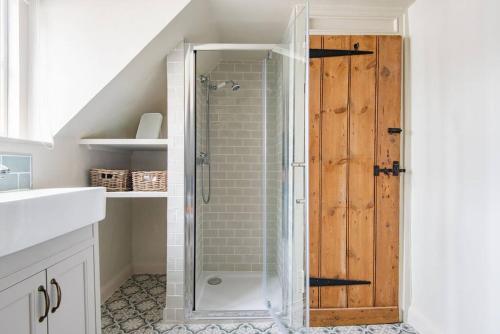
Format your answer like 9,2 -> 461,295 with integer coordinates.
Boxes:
309,36 -> 402,326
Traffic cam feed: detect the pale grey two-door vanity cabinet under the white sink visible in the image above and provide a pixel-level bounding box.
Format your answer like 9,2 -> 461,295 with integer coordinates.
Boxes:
0,225 -> 100,334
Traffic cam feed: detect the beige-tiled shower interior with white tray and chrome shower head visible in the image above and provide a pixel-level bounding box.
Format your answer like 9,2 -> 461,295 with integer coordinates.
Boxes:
195,51 -> 282,310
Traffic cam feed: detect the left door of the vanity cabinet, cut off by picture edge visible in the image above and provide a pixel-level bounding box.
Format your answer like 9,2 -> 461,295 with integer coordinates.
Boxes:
0,271 -> 47,334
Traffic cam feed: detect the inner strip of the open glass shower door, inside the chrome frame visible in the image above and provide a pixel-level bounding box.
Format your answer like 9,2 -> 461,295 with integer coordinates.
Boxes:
264,53 -> 288,314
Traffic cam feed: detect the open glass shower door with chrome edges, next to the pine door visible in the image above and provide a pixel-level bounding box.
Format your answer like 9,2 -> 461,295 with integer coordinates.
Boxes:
264,2 -> 309,330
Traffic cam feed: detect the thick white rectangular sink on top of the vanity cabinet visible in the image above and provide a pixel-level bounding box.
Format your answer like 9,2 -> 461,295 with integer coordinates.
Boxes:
0,188 -> 106,257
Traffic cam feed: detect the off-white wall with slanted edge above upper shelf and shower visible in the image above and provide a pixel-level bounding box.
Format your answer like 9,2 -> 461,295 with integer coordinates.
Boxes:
57,0 -> 295,138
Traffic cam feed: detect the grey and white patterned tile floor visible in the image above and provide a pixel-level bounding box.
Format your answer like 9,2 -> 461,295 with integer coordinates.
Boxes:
101,275 -> 417,334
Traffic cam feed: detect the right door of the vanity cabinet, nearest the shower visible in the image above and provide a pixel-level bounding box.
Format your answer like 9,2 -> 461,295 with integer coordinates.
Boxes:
47,247 -> 96,334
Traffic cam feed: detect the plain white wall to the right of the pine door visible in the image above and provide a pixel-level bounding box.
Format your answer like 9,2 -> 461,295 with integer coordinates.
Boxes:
408,0 -> 500,334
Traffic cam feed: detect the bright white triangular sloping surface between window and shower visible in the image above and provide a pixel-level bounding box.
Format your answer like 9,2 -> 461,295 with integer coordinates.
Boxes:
39,0 -> 190,133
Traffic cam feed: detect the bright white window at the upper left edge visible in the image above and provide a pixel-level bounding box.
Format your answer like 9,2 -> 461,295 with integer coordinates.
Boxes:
0,0 -> 35,139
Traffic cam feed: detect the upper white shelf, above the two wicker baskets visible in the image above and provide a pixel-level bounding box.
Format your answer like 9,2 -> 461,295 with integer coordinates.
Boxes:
80,139 -> 168,151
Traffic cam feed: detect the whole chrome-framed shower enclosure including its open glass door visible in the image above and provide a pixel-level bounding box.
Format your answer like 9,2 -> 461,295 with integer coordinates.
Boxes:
185,7 -> 308,328
